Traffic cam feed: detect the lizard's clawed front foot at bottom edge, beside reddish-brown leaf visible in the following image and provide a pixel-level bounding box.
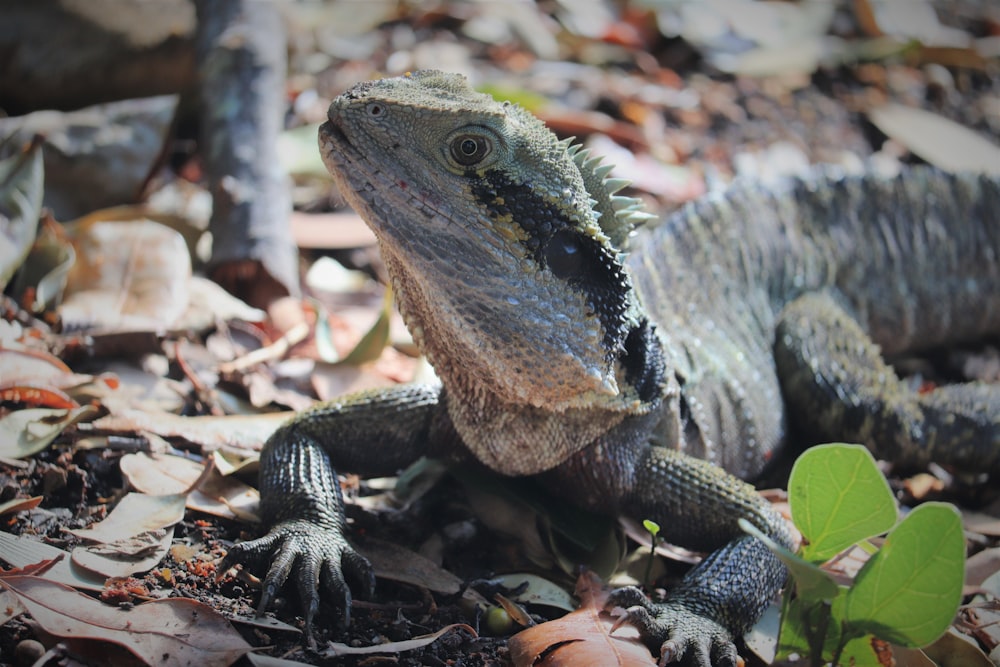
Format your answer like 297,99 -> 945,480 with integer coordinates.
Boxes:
605,586 -> 744,667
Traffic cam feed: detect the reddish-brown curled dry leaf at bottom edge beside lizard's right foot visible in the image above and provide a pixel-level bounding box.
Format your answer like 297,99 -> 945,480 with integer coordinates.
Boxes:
508,572 -> 656,667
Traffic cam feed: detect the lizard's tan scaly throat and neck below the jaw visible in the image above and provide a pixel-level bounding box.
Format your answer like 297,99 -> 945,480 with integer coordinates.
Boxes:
385,245 -> 666,475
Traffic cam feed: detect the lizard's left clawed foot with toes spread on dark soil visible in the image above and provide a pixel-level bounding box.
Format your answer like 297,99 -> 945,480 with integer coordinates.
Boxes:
217,519 -> 375,647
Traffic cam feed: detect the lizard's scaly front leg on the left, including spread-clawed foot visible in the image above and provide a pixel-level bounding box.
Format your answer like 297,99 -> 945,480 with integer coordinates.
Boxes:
225,386 -> 448,645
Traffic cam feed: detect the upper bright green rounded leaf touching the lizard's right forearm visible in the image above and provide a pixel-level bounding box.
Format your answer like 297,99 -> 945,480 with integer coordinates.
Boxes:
788,444 -> 896,563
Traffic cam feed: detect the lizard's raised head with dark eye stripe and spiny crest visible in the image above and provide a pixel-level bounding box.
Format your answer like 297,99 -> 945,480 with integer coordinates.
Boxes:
320,71 -> 655,410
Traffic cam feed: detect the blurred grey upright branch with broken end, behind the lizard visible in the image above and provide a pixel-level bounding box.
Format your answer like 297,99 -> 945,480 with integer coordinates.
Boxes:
195,0 -> 298,305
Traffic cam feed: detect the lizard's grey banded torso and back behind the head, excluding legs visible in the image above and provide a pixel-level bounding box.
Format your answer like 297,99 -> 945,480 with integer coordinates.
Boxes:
629,168 -> 1000,476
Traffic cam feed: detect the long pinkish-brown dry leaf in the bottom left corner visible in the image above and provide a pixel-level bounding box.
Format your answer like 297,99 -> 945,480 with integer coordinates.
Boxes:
0,575 -> 251,667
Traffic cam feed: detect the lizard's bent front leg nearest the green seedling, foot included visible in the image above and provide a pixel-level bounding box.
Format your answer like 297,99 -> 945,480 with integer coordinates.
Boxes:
549,436 -> 793,667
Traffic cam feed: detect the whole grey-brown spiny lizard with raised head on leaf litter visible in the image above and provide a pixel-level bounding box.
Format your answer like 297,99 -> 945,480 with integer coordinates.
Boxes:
220,70 -> 1000,666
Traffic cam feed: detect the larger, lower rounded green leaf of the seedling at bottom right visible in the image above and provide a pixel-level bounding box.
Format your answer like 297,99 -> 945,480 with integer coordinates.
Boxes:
846,503 -> 965,647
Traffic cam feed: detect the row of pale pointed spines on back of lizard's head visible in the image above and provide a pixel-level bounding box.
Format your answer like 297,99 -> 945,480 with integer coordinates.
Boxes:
562,137 -> 656,251
